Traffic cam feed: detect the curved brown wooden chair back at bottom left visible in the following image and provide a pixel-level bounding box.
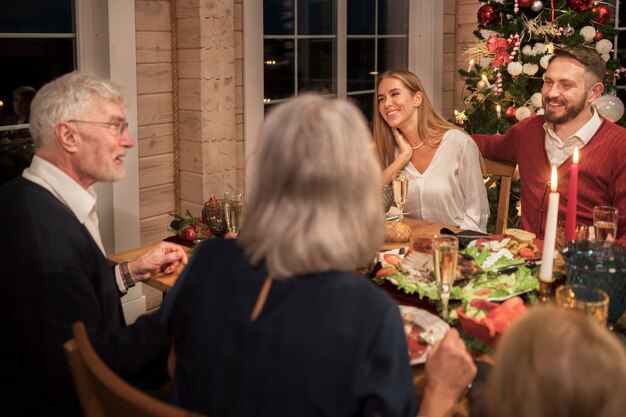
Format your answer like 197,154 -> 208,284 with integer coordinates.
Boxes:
64,322 -> 200,417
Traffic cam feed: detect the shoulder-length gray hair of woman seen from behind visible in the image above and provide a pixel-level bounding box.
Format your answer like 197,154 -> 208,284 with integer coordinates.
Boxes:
237,94 -> 384,278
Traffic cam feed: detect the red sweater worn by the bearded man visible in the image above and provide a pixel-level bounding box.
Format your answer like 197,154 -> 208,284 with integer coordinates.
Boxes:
472,116 -> 626,240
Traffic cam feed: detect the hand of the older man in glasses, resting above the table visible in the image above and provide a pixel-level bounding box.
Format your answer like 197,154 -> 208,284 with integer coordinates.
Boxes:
128,242 -> 188,281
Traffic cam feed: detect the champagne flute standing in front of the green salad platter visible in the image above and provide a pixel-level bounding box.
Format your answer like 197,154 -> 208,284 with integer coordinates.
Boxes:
433,235 -> 459,321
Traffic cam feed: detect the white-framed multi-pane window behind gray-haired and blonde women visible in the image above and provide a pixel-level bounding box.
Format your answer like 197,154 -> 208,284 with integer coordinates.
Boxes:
263,0 -> 409,118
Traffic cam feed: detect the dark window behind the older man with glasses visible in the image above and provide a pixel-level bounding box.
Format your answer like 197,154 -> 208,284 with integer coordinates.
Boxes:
0,0 -> 76,183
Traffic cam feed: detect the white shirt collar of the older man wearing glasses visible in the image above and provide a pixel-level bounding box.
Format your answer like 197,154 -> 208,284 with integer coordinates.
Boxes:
22,155 -> 96,234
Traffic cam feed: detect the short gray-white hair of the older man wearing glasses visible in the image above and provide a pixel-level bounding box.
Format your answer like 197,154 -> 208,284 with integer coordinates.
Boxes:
30,72 -> 126,148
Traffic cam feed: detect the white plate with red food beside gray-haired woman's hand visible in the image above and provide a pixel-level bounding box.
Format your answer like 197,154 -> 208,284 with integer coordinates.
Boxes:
399,305 -> 450,365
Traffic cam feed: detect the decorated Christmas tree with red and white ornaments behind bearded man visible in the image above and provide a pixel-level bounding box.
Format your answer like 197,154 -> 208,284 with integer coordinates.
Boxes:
455,0 -> 626,230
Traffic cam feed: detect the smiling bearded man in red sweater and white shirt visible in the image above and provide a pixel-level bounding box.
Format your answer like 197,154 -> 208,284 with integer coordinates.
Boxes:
472,46 -> 626,240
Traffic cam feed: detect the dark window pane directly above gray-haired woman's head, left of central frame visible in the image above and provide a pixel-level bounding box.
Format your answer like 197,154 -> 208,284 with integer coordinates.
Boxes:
298,39 -> 336,93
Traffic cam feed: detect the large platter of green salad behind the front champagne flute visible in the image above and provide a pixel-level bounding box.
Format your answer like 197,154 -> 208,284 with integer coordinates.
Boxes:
373,231 -> 542,303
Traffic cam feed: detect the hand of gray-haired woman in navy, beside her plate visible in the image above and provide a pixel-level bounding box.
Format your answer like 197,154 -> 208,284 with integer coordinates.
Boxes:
419,329 -> 476,417
